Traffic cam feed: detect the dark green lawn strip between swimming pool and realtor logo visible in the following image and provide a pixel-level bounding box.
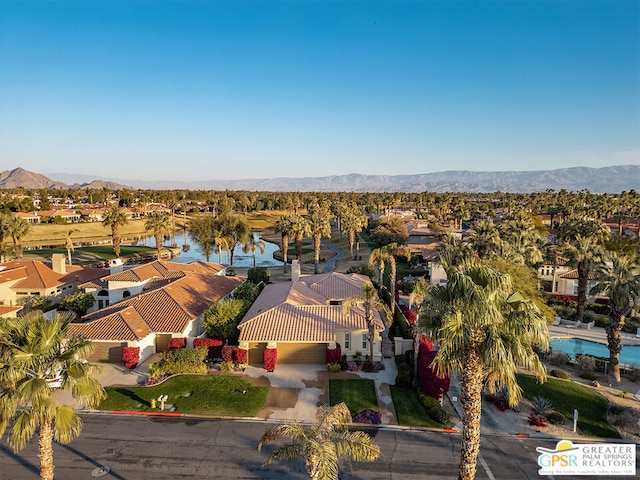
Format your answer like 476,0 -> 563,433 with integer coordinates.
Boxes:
518,375 -> 620,438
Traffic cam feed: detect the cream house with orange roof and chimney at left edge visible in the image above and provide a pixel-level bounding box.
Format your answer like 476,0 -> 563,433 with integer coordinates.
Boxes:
0,253 -> 108,312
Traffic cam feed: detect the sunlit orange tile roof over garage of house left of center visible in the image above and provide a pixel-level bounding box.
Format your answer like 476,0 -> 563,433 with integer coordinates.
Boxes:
73,273 -> 242,340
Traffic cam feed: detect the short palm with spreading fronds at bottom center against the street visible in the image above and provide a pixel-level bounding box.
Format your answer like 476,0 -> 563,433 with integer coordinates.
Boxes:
258,403 -> 380,480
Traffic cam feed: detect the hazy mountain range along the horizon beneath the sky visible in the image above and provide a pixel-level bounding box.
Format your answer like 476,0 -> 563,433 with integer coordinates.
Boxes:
0,165 -> 640,193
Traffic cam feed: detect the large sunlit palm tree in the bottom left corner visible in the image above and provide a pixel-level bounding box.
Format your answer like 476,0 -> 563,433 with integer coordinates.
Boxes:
0,312 -> 105,480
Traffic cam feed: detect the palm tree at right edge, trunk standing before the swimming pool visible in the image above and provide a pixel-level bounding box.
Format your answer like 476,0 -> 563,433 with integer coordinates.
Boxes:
590,255 -> 640,383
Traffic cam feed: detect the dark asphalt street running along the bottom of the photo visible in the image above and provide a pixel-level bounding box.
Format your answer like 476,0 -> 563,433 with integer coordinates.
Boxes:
0,414 -> 628,480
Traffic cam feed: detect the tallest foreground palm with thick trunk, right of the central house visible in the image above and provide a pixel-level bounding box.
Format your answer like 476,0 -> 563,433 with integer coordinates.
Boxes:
418,262 -> 549,480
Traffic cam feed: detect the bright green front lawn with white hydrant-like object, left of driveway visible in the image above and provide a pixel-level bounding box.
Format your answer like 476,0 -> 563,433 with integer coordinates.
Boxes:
99,375 -> 269,417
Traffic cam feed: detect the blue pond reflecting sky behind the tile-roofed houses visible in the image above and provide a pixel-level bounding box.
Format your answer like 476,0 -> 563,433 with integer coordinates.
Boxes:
123,232 -> 282,268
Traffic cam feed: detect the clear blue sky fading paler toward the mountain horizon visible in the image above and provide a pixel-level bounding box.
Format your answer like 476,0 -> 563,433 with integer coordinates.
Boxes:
0,0 -> 640,181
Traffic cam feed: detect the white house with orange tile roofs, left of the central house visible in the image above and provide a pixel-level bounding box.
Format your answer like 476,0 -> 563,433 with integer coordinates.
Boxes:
69,262 -> 242,363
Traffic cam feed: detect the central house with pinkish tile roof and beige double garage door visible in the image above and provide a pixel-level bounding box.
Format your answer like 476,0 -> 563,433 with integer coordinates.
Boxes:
238,273 -> 384,364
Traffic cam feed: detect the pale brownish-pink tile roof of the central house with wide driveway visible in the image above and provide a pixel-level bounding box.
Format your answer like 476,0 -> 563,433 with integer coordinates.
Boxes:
238,272 -> 384,342
